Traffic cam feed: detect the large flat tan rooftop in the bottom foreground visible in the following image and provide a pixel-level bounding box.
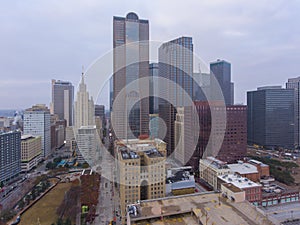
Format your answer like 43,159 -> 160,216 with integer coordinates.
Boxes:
129,192 -> 269,225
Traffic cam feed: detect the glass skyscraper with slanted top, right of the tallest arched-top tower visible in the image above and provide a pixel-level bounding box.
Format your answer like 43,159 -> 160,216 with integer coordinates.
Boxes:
158,37 -> 194,156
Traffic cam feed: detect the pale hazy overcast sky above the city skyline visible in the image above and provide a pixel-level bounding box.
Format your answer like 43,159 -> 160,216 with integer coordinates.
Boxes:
0,0 -> 300,109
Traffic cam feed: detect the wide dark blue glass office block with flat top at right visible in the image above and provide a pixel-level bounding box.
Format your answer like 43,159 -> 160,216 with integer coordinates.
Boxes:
247,86 -> 295,148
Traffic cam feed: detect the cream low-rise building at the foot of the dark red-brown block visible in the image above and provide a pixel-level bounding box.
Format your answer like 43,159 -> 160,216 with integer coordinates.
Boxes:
199,157 -> 230,190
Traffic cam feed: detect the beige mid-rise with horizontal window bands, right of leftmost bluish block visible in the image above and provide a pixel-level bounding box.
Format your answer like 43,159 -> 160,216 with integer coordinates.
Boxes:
21,135 -> 42,172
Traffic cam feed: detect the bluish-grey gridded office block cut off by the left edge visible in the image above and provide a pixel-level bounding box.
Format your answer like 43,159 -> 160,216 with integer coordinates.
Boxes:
0,131 -> 21,182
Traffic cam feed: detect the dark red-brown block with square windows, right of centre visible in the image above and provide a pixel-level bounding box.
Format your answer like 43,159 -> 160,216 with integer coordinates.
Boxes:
194,101 -> 247,168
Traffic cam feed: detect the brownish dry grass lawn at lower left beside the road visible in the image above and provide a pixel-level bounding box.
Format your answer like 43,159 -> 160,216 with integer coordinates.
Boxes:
19,183 -> 72,225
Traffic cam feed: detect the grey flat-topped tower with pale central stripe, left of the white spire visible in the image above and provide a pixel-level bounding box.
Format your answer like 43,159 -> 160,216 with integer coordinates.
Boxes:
51,80 -> 74,126
